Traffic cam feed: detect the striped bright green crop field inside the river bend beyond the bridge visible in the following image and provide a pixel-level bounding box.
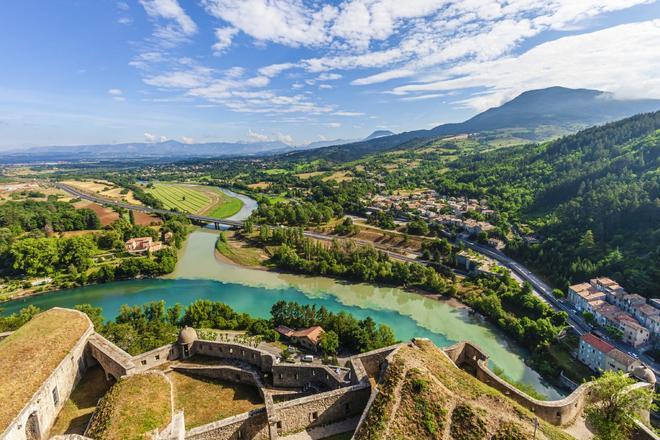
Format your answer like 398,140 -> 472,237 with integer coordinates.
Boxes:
147,183 -> 243,218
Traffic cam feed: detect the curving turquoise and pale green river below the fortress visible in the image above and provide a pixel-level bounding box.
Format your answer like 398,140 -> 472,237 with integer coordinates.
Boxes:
2,229 -> 561,399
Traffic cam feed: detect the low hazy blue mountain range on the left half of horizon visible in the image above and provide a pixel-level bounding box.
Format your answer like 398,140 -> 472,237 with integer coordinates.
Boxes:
2,140 -> 294,162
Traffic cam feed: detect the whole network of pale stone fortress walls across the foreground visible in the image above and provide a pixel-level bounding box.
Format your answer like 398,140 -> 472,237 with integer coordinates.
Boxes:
9,312 -> 656,440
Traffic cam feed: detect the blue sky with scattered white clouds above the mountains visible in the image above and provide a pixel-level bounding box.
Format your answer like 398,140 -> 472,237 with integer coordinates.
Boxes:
0,0 -> 660,150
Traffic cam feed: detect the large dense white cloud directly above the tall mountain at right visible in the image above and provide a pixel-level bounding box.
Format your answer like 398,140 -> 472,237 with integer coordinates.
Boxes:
393,20 -> 660,110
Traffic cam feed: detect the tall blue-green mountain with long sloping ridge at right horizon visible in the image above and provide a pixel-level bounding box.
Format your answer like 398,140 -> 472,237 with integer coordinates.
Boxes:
291,87 -> 660,161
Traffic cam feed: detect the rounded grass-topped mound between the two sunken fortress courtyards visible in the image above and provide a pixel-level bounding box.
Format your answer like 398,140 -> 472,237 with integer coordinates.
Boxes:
88,374 -> 172,440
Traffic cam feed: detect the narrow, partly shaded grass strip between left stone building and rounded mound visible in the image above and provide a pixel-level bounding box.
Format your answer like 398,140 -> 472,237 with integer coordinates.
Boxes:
50,366 -> 110,435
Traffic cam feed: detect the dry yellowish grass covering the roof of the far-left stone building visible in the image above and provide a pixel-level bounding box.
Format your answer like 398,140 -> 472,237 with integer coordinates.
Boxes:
0,309 -> 91,432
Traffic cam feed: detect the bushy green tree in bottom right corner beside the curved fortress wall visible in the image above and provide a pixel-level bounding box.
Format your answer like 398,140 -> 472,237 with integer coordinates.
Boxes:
585,371 -> 655,440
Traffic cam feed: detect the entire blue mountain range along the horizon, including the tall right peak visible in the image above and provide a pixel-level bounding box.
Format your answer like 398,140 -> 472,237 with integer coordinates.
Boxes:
0,87 -> 660,163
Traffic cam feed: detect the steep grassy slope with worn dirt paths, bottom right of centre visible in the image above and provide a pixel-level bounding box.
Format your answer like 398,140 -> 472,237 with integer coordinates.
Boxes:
355,341 -> 571,440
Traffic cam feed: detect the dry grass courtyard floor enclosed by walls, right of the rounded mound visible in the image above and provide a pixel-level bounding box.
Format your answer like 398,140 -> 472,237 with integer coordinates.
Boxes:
169,371 -> 263,429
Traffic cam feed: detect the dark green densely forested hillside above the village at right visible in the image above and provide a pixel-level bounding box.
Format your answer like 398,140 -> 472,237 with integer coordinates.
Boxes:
437,112 -> 660,296
